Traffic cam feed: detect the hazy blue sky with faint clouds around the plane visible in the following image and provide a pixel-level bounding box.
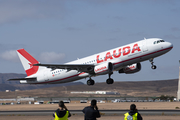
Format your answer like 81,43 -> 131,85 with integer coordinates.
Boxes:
0,0 -> 180,82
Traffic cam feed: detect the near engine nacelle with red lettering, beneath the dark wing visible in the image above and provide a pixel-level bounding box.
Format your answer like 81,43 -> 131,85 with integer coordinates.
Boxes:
94,62 -> 114,75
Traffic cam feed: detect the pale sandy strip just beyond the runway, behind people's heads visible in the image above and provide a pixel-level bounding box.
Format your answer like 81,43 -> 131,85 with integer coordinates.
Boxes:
0,102 -> 180,111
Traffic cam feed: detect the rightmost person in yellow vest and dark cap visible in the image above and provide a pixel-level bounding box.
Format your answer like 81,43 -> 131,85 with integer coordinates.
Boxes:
124,104 -> 142,120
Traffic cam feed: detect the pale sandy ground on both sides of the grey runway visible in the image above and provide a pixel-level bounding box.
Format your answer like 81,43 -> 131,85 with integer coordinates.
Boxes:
0,102 -> 180,120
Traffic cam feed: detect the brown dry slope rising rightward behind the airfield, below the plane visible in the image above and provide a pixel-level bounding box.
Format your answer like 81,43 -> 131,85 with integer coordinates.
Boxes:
0,79 -> 178,99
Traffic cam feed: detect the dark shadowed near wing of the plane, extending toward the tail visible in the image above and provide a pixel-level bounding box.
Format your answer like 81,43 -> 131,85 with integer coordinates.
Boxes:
34,64 -> 95,73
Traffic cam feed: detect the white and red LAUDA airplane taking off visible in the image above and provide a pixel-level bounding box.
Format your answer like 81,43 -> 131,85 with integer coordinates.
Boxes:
9,38 -> 173,86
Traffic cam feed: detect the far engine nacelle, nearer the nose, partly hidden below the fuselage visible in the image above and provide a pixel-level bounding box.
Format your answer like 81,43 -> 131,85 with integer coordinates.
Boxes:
119,63 -> 141,74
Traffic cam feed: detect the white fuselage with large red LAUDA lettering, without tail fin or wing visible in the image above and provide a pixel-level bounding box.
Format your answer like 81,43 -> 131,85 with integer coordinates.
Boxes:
20,38 -> 173,84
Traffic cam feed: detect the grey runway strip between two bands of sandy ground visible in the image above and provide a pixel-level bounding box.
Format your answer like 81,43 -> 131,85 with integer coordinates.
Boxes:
0,110 -> 180,116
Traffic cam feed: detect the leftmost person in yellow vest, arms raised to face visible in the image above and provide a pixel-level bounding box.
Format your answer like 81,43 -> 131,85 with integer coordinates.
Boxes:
53,101 -> 71,120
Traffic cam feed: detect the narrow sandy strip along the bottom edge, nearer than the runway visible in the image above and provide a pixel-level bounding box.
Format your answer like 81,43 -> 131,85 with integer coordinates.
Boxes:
0,116 -> 180,120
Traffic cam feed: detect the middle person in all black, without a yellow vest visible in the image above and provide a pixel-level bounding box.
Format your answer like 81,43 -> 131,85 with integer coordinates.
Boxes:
82,99 -> 101,120
